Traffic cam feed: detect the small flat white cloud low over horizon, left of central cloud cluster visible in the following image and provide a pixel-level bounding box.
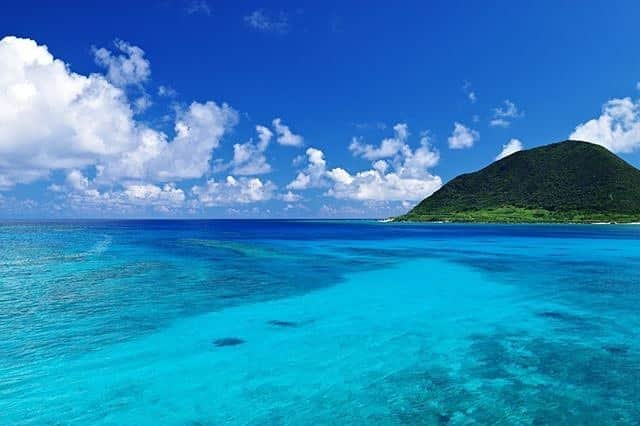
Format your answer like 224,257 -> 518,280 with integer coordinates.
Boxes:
191,176 -> 277,207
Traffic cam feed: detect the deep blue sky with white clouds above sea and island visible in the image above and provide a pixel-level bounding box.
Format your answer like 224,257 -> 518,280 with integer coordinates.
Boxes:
0,0 -> 640,217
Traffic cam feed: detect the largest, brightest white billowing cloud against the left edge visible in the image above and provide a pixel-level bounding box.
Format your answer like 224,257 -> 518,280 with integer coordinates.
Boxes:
0,37 -> 136,186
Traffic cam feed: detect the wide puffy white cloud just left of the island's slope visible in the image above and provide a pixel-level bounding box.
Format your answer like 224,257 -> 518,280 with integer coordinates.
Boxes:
288,124 -> 442,201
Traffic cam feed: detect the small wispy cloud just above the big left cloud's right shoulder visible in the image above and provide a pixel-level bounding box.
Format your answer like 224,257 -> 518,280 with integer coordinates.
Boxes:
93,40 -> 151,87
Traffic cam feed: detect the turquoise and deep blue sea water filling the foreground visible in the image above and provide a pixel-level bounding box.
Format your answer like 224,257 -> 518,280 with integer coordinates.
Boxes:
0,221 -> 640,425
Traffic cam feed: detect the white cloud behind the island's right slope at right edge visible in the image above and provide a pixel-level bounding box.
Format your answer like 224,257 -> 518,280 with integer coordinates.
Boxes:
569,97 -> 640,152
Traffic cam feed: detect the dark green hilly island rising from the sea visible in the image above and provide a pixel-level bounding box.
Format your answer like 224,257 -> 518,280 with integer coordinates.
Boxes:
394,140 -> 640,223
